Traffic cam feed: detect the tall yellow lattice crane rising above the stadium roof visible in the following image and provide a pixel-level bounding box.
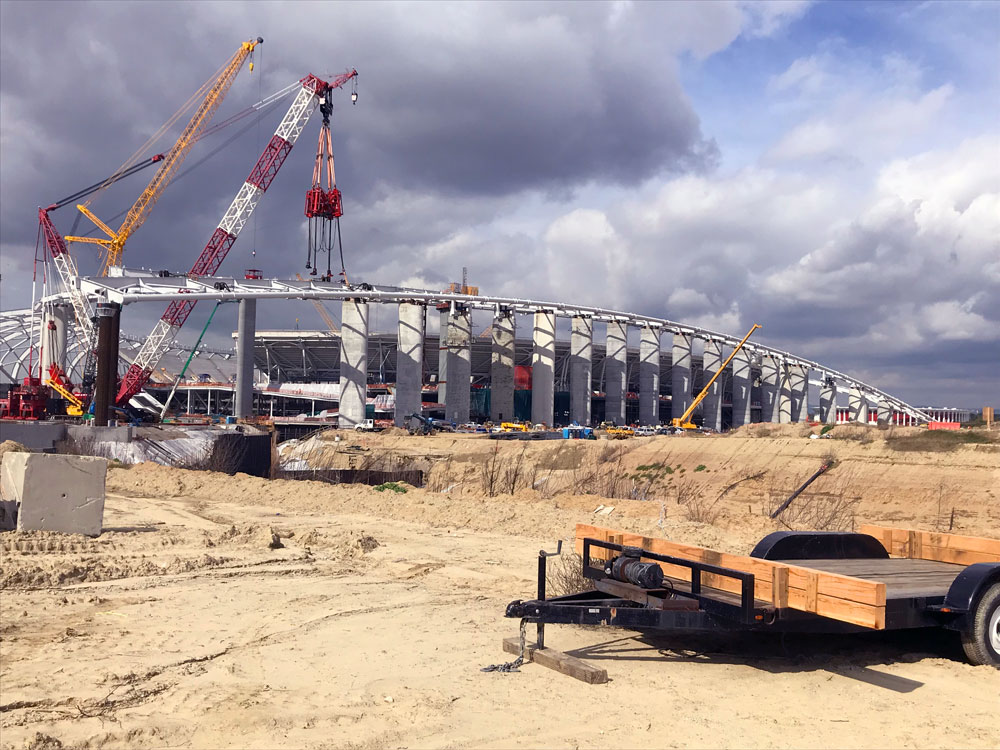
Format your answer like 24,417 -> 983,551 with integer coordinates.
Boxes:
66,37 -> 264,276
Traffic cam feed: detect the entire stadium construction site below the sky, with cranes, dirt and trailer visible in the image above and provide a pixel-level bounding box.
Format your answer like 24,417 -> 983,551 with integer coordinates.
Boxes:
0,26 -> 1000,750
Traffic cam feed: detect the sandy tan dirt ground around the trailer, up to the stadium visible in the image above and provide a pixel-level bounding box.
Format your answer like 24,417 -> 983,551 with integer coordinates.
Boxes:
0,428 -> 1000,750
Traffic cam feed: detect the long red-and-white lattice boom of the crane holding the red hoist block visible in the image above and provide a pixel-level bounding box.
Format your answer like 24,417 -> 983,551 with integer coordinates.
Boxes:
116,70 -> 358,412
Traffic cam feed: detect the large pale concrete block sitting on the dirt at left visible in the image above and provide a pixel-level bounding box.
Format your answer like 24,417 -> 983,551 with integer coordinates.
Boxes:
0,453 -> 108,536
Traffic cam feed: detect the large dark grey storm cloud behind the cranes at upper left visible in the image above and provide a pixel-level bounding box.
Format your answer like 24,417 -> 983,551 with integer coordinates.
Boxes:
0,3 -> 733,317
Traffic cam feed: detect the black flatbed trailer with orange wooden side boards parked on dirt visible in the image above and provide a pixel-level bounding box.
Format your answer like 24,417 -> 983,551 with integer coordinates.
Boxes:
505,524 -> 1000,680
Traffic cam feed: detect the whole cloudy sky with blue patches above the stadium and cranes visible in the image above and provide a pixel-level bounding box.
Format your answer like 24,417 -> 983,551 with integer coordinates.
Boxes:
0,0 -> 1000,406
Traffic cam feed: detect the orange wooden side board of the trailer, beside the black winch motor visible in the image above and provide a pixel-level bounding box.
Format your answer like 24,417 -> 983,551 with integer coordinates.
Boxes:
576,524 -> 886,629
